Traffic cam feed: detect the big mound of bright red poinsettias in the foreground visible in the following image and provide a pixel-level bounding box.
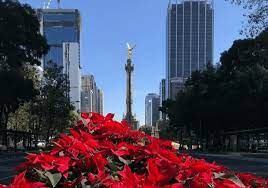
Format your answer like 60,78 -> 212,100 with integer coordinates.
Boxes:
0,113 -> 268,188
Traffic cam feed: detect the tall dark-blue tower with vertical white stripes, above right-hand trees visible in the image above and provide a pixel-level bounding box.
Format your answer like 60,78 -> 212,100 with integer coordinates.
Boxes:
166,0 -> 214,99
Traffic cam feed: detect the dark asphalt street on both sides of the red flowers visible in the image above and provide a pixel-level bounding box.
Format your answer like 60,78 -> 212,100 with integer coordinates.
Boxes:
0,153 -> 268,184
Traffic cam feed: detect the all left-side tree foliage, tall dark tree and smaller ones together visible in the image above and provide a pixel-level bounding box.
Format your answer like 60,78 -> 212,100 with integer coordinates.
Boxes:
0,0 -> 76,146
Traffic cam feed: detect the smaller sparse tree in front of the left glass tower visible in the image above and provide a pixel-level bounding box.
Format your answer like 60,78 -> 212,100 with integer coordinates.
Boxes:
38,62 -> 75,141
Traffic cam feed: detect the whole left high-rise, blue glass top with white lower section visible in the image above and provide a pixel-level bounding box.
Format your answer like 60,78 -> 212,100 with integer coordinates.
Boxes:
37,9 -> 81,111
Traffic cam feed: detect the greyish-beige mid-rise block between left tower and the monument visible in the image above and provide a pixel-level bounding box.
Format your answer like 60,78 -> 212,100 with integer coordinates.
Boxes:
81,75 -> 103,114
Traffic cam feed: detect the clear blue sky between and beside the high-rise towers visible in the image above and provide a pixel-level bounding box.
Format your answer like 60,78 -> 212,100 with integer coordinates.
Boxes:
21,0 -> 245,125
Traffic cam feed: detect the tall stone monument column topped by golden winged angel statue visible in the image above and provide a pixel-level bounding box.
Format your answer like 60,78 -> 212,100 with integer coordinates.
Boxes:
124,44 -> 138,130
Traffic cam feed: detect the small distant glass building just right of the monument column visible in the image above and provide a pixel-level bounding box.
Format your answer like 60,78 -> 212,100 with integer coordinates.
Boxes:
145,93 -> 160,126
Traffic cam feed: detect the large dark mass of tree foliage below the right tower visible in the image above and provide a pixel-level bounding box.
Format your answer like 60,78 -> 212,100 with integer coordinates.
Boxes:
161,29 -> 268,143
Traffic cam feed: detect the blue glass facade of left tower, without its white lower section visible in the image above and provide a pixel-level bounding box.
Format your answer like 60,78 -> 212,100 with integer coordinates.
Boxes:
37,9 -> 80,66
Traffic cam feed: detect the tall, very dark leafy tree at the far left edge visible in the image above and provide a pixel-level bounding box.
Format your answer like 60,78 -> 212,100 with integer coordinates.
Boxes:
0,0 -> 48,144
